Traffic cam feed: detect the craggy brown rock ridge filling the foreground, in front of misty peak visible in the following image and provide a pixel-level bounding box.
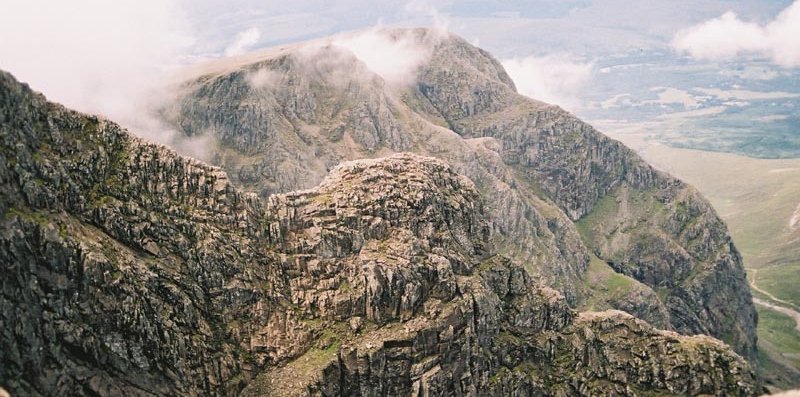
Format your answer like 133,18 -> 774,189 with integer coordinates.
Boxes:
0,73 -> 757,396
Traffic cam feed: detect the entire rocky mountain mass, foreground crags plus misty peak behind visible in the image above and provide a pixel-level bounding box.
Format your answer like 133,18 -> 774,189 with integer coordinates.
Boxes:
0,30 -> 760,396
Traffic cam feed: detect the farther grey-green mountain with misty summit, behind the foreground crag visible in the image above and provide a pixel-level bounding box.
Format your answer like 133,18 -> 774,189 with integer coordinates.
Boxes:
164,29 -> 756,359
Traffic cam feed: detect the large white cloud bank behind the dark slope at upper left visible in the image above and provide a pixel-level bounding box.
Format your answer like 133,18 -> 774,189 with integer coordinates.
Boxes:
0,0 -> 209,156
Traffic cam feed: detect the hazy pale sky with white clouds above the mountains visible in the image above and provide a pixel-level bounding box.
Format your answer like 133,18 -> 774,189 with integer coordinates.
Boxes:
0,0 -> 800,153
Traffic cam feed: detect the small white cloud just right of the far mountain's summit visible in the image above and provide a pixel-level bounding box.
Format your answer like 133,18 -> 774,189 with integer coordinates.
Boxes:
502,55 -> 594,110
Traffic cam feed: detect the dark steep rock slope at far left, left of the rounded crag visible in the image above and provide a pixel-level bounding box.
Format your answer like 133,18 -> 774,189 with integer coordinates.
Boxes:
0,69 -> 282,395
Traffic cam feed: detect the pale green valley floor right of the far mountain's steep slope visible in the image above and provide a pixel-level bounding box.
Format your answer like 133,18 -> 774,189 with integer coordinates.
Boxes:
616,142 -> 800,389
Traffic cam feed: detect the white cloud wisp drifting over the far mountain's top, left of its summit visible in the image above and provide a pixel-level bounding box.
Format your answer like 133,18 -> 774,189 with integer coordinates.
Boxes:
332,27 -> 444,85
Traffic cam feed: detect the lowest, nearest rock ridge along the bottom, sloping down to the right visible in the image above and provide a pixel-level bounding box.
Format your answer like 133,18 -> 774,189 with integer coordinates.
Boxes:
243,258 -> 757,396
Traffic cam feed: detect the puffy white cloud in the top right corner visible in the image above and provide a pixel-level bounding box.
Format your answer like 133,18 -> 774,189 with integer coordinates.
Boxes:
671,0 -> 800,67
